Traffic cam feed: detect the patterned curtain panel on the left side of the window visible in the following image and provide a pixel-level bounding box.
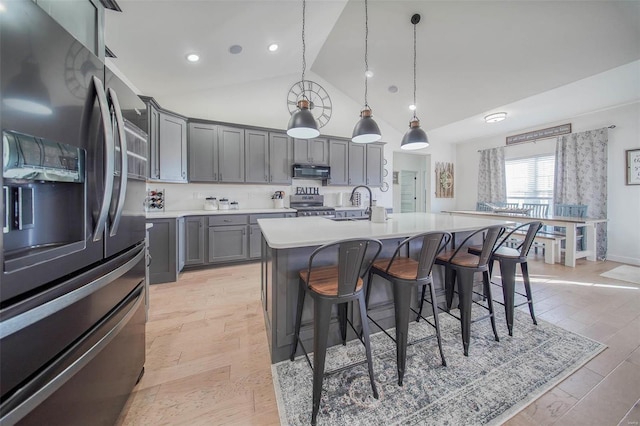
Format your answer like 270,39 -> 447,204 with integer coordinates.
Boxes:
478,147 -> 507,203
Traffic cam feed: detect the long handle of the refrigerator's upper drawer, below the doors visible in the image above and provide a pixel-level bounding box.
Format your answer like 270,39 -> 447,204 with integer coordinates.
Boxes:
0,249 -> 145,339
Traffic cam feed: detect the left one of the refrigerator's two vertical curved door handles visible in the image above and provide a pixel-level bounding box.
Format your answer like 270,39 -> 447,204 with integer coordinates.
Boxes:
93,75 -> 115,241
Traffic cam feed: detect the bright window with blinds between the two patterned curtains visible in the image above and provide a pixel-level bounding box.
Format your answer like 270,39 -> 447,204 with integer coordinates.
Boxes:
505,155 -> 555,205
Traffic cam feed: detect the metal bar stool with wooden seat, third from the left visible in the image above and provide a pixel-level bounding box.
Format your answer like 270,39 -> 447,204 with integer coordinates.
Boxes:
436,225 -> 504,356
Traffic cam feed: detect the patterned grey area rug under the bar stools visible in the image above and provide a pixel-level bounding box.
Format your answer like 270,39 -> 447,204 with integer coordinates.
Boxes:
272,306 -> 606,425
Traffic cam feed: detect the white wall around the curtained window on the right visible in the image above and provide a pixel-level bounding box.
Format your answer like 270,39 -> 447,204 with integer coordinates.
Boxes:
455,102 -> 640,265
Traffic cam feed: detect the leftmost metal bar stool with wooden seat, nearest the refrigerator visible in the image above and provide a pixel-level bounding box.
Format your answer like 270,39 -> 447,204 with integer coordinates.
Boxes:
290,239 -> 382,425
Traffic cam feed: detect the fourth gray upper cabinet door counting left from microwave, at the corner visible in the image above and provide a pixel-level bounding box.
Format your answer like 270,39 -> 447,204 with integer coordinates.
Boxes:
189,123 -> 218,182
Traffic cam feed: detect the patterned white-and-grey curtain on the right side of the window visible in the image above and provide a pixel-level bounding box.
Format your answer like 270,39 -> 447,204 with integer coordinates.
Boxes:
553,127 -> 608,259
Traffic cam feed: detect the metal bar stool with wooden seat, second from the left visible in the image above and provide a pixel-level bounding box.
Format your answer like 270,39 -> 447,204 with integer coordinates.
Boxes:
366,232 -> 451,386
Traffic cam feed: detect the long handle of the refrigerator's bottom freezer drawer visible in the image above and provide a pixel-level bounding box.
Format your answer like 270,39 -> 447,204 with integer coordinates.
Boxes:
1,288 -> 144,425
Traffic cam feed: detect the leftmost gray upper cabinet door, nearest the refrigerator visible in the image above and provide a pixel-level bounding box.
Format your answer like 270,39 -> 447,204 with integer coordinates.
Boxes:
157,111 -> 187,182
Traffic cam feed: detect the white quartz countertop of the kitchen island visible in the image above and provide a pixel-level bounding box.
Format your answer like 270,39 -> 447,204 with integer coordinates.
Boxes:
258,213 -> 513,249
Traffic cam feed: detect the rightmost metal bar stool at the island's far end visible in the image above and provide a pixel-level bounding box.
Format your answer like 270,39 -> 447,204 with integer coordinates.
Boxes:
469,221 -> 542,336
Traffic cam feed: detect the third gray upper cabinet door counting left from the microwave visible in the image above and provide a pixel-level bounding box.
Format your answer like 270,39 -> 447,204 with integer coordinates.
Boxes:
218,126 -> 245,183
